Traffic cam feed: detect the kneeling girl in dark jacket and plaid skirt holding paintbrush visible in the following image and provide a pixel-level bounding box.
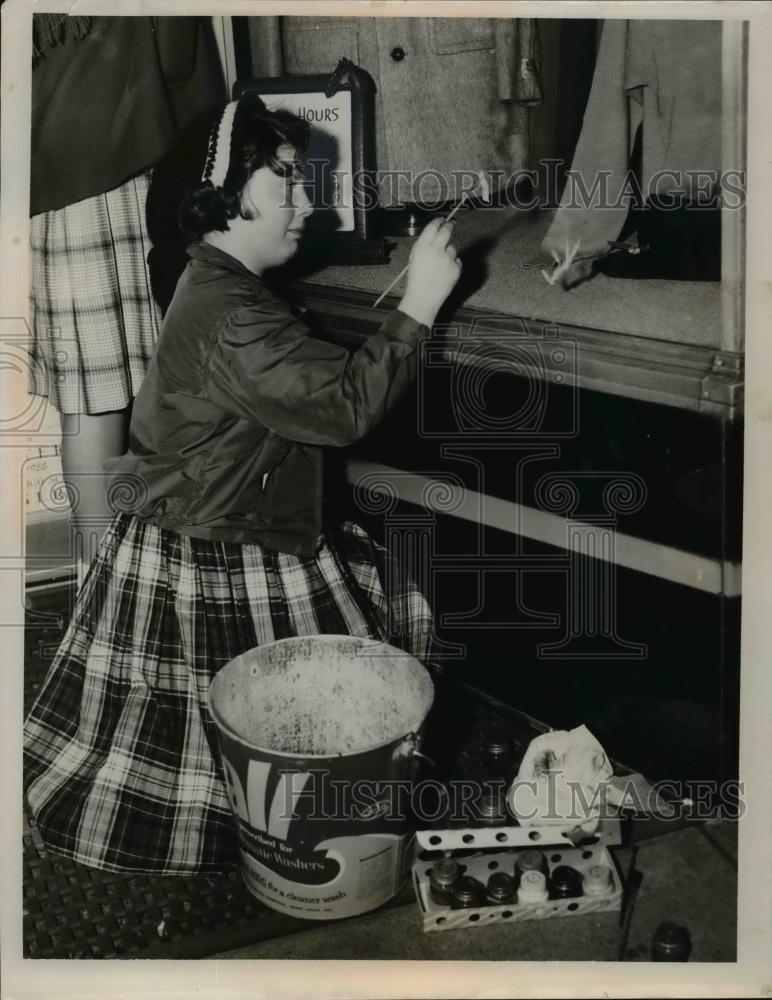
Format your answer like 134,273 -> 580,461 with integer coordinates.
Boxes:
24,96 -> 461,874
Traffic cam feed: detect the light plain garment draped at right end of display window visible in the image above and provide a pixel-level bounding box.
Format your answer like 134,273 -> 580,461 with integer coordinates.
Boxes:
542,20 -> 721,255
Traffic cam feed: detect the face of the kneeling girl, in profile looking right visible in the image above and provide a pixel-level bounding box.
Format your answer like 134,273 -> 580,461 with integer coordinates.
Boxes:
242,146 -> 313,270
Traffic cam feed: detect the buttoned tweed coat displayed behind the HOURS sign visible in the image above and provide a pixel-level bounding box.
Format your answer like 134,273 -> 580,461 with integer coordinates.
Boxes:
252,17 -> 541,205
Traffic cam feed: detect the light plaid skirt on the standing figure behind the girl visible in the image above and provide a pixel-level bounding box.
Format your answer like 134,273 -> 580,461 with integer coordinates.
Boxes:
28,174 -> 160,414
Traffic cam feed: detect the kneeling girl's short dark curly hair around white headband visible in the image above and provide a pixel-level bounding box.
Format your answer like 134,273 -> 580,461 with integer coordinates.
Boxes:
179,94 -> 309,240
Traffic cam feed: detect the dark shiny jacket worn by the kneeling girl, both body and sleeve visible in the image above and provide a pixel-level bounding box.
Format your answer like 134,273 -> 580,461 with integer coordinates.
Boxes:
106,243 -> 428,555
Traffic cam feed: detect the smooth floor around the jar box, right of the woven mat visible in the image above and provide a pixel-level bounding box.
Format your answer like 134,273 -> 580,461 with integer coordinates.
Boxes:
213,823 -> 737,962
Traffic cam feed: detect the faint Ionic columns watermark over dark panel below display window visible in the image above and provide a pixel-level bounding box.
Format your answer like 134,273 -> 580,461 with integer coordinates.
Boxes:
354,454 -> 647,660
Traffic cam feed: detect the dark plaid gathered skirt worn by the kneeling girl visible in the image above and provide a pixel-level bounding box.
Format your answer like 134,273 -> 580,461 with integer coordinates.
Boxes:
24,514 -> 432,874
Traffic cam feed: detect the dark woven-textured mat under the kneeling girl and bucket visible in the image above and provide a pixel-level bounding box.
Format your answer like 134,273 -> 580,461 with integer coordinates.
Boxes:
22,588 -> 316,958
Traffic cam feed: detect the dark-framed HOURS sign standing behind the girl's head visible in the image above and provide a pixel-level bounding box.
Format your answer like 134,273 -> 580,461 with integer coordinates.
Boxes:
233,59 -> 391,264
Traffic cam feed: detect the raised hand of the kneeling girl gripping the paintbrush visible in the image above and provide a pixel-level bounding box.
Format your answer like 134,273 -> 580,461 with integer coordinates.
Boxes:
399,219 -> 461,327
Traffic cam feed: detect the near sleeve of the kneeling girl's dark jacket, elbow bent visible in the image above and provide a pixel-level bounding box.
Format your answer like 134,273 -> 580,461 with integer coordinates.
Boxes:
207,302 -> 428,445
